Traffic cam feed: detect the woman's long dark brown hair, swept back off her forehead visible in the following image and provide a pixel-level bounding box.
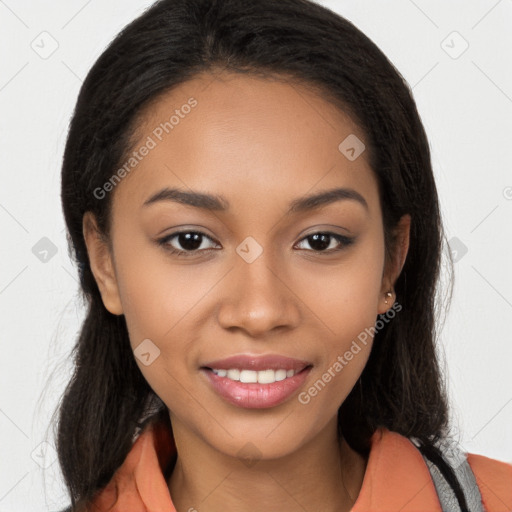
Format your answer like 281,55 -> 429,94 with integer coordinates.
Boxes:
56,0 -> 456,510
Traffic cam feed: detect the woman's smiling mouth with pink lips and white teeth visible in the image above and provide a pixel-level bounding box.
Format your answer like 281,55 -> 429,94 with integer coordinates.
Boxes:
200,355 -> 313,409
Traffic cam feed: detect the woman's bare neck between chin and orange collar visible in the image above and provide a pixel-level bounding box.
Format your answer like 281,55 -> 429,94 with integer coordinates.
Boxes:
169,421 -> 366,512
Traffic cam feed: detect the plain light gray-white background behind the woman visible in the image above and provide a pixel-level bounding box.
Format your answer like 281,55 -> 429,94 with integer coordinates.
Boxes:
0,0 -> 512,512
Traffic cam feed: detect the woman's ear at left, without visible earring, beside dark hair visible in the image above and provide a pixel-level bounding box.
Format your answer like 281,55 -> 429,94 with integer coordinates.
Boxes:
82,212 -> 123,315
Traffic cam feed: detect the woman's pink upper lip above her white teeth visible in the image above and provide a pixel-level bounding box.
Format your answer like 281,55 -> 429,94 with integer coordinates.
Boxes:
202,354 -> 311,372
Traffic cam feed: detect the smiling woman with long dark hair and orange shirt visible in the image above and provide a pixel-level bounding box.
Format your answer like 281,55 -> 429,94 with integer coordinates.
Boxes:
57,0 -> 512,512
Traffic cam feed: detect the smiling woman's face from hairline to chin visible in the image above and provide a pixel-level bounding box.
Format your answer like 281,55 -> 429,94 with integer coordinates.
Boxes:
84,73 -> 410,458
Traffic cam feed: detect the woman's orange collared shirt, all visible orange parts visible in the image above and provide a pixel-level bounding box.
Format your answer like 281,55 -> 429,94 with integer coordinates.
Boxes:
90,423 -> 512,512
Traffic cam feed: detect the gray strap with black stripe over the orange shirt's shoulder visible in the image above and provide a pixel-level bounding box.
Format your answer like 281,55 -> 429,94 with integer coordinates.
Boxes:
413,439 -> 485,512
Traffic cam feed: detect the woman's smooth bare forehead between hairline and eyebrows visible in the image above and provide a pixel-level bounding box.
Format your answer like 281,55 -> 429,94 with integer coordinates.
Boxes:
110,72 -> 378,218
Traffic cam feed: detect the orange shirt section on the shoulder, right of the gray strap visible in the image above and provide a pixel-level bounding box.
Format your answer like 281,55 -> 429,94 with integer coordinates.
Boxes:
467,453 -> 512,512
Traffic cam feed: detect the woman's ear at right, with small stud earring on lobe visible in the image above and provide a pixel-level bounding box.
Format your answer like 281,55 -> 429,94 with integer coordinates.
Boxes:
378,213 -> 411,314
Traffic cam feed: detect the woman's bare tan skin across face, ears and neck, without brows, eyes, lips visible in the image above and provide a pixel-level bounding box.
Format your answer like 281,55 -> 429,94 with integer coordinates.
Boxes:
83,72 -> 410,512
